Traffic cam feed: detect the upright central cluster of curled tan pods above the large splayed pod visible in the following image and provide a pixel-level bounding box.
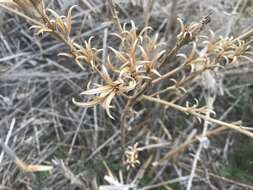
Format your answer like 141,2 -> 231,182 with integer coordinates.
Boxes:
108,21 -> 165,80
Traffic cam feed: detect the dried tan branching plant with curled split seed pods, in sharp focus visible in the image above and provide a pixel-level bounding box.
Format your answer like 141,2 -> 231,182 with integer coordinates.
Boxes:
0,0 -> 253,171
